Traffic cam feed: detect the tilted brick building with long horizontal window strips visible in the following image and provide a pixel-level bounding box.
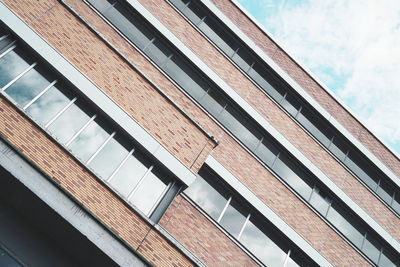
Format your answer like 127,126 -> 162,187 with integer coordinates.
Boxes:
0,0 -> 400,266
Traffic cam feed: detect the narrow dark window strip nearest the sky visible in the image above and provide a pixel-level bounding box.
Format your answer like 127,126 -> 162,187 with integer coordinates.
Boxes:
169,0 -> 400,218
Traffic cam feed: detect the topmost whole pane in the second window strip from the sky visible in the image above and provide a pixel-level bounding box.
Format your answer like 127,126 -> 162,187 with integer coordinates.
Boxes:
103,2 -> 154,49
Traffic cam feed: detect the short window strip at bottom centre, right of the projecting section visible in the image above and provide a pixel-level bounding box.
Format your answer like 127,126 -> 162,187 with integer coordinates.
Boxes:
184,165 -> 318,267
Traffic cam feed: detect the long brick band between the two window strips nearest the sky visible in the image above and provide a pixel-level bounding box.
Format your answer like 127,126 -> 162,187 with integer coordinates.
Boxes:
141,0 -> 400,243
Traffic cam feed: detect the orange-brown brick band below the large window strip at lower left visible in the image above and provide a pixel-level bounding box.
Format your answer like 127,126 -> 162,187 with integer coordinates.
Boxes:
0,96 -> 192,266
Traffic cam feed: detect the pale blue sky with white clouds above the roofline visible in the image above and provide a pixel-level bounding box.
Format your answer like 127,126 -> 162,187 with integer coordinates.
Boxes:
238,0 -> 400,155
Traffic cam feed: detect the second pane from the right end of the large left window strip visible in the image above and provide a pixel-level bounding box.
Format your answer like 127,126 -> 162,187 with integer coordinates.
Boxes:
110,153 -> 150,197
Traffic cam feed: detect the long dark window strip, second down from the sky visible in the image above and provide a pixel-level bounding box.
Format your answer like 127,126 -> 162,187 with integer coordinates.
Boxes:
88,0 -> 398,266
